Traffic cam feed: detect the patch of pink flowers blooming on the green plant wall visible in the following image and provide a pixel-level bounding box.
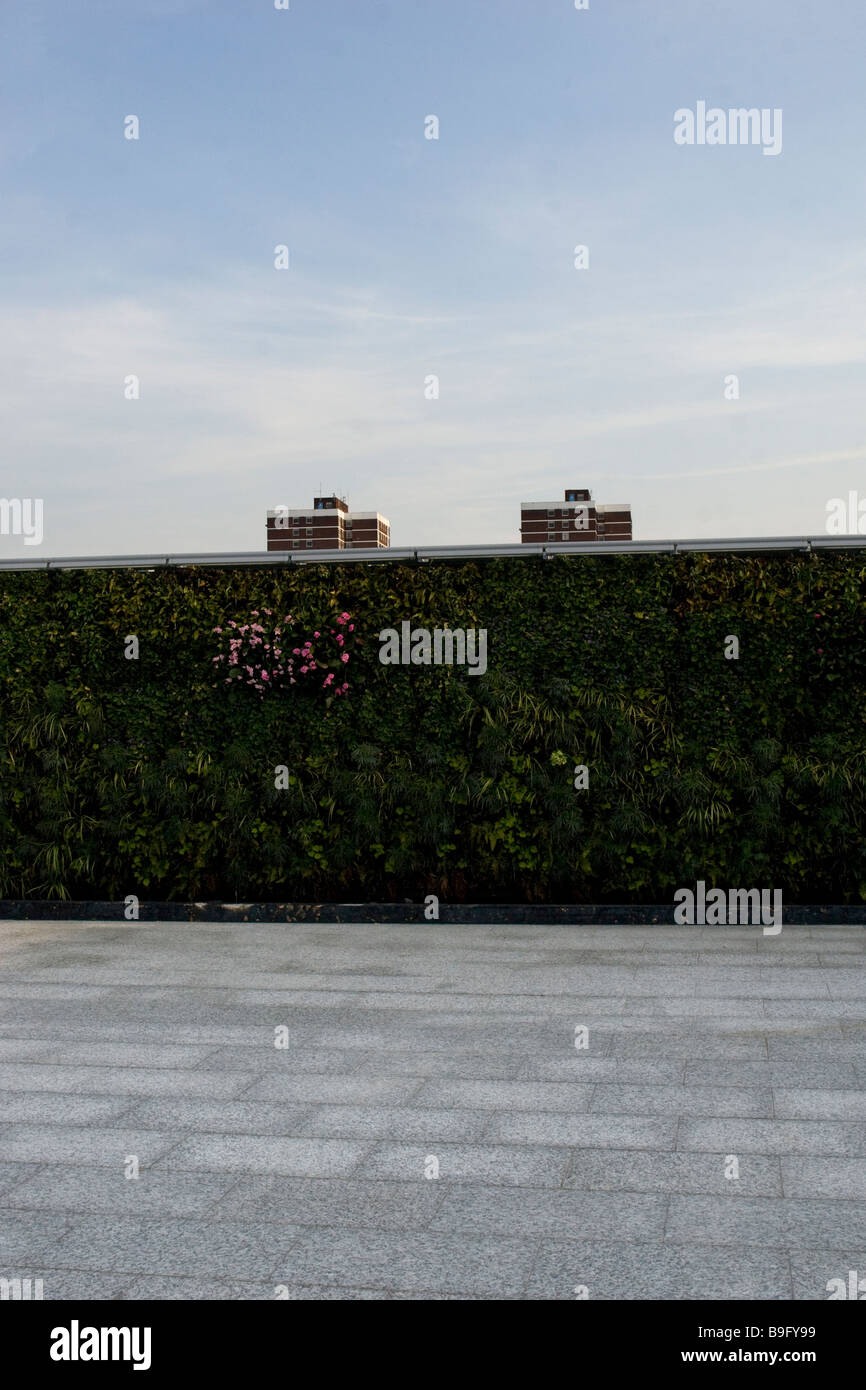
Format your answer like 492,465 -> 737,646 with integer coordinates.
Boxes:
213,609 -> 354,696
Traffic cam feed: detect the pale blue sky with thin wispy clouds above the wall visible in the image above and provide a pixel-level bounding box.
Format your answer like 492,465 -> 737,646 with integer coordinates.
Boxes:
0,0 -> 866,559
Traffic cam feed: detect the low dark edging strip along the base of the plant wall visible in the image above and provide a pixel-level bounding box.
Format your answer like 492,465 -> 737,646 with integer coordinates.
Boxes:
0,898 -> 866,927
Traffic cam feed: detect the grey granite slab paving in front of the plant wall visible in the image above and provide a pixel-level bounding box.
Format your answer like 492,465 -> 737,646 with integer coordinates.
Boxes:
0,922 -> 866,1300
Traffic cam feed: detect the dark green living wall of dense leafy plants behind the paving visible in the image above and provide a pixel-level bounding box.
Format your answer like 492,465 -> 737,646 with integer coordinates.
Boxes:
0,550 -> 866,904
